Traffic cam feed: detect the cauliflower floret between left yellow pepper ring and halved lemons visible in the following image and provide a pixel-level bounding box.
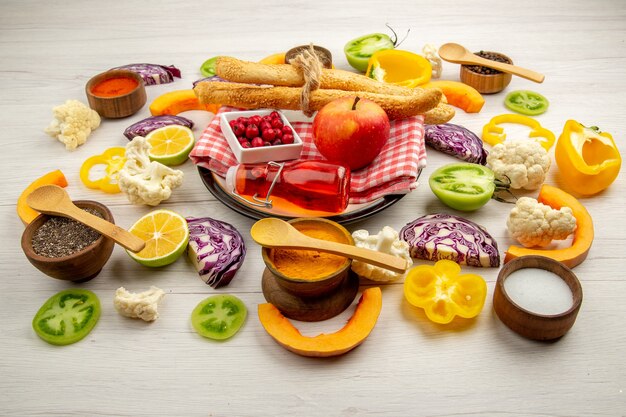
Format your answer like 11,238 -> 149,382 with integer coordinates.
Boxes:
119,136 -> 183,206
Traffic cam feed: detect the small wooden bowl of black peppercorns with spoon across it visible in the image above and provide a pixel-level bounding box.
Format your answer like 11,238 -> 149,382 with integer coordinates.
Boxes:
461,51 -> 513,94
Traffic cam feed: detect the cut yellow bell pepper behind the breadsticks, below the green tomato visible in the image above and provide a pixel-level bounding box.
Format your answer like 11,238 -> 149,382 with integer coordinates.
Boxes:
365,49 -> 433,88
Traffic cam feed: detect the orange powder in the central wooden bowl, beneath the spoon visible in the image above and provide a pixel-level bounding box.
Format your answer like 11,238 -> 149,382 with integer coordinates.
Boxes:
270,223 -> 349,280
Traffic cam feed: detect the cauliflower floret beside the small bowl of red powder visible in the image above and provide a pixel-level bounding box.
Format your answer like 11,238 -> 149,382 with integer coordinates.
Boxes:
45,100 -> 100,151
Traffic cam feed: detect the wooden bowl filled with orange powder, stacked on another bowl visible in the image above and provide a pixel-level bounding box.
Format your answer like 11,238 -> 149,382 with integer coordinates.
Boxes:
262,218 -> 354,297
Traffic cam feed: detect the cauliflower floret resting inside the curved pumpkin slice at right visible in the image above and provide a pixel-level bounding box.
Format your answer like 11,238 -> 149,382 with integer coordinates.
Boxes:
506,197 -> 576,248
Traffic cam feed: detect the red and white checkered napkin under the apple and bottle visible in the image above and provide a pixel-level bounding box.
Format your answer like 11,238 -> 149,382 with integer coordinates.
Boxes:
189,106 -> 426,204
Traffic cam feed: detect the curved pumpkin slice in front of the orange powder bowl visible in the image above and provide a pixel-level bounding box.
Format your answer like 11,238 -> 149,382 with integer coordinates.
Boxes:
259,287 -> 383,357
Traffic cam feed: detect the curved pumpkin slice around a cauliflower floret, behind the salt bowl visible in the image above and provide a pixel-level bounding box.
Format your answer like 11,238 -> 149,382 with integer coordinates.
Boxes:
504,185 -> 593,268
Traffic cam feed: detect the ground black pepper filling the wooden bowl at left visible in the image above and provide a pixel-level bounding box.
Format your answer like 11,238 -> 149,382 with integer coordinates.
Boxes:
32,208 -> 103,258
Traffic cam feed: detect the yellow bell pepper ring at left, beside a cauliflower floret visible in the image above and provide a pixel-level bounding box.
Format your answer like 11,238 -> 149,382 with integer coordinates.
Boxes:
80,146 -> 126,194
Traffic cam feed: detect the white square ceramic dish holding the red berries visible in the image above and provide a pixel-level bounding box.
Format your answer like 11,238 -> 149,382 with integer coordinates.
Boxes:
220,110 -> 302,164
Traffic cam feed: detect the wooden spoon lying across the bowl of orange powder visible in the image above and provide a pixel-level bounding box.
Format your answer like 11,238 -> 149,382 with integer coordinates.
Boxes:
250,218 -> 408,274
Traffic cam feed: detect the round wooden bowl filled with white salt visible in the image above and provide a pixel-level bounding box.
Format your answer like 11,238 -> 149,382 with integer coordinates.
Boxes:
493,256 -> 583,340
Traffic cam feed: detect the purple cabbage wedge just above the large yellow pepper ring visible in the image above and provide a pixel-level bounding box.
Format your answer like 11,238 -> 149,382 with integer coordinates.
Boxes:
400,213 -> 500,267
